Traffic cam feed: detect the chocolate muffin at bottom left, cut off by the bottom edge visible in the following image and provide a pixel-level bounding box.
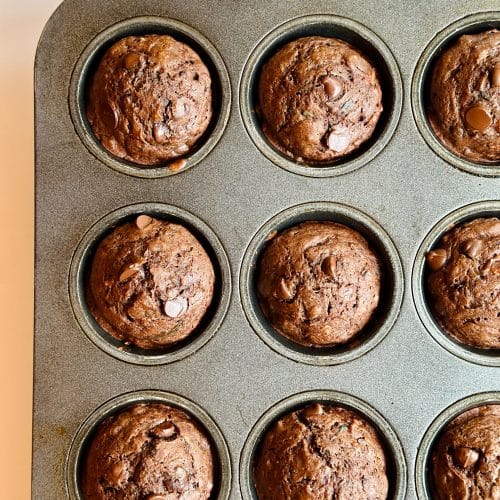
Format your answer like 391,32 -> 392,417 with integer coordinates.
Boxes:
80,403 -> 214,500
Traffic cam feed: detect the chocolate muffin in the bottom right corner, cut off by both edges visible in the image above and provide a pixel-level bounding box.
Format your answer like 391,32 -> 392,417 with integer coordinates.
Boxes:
430,405 -> 500,500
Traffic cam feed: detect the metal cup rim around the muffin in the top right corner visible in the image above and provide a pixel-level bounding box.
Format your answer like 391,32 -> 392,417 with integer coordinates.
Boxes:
411,11 -> 500,177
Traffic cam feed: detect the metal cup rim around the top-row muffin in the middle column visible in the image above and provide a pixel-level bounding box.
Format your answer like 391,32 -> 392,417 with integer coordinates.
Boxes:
239,14 -> 403,177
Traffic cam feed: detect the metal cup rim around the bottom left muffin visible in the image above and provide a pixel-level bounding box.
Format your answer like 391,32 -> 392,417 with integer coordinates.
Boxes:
65,390 -> 232,500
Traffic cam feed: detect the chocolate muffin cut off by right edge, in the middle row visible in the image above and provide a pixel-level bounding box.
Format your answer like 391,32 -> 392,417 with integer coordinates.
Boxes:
427,217 -> 500,349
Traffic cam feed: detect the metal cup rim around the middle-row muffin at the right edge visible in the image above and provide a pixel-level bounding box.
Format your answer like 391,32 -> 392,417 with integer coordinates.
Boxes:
411,200 -> 500,366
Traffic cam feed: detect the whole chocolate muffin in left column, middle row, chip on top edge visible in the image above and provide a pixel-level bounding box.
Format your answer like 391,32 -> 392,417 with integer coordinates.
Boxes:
86,215 -> 215,349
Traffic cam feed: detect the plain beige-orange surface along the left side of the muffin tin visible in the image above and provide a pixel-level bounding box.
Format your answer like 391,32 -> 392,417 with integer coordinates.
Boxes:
0,0 -> 60,500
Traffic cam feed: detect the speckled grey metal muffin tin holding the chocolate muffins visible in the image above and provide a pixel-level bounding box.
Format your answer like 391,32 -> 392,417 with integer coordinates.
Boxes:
32,0 -> 500,499
